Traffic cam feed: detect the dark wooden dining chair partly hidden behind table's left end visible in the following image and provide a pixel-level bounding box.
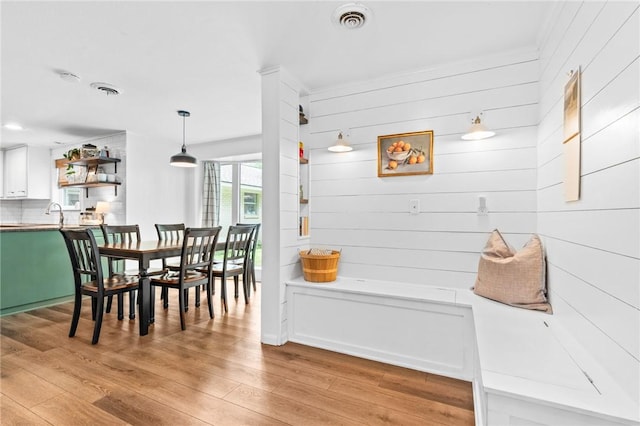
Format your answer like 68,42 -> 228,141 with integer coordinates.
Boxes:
100,225 -> 140,319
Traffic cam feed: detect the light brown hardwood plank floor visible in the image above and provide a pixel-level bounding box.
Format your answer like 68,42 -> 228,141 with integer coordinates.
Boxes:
0,285 -> 474,426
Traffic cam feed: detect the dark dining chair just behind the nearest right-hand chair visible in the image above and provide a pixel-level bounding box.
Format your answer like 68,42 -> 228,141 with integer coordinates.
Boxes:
212,225 -> 255,312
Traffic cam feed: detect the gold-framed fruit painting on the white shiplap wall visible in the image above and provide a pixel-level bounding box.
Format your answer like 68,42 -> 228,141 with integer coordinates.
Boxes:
378,130 -> 433,177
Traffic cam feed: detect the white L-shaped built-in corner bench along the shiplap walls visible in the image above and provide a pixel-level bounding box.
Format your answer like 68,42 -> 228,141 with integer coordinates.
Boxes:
286,277 -> 640,426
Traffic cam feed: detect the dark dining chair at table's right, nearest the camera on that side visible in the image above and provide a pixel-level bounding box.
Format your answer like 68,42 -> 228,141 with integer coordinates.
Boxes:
150,226 -> 221,330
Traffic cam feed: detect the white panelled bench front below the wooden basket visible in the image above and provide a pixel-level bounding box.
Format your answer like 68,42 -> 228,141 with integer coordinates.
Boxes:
287,280 -> 473,381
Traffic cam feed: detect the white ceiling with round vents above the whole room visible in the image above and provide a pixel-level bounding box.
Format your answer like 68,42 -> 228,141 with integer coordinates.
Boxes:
0,0 -> 555,147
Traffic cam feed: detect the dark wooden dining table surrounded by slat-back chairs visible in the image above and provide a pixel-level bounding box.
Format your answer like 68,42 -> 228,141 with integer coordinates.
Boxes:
98,240 -> 182,336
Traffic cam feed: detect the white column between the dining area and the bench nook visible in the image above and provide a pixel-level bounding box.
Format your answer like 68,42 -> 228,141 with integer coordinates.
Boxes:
260,67 -> 300,345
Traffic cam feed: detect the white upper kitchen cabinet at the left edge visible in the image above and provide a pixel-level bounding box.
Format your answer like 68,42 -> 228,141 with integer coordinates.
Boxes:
3,146 -> 51,199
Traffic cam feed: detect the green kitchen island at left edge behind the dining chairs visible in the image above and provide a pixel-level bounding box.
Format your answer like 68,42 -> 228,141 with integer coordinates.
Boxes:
0,225 -> 84,315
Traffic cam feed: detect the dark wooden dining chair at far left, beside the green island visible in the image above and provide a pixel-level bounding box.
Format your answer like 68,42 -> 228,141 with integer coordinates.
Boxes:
60,229 -> 138,345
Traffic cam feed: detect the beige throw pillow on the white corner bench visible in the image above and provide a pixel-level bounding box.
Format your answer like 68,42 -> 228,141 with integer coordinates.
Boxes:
473,229 -> 552,313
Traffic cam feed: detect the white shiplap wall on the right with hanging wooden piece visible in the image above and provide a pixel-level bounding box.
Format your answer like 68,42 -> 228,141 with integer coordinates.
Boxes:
537,2 -> 640,400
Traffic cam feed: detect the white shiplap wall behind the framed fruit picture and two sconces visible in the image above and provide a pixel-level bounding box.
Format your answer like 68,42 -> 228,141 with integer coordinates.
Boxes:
304,52 -> 539,288
